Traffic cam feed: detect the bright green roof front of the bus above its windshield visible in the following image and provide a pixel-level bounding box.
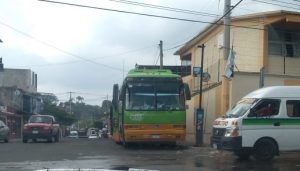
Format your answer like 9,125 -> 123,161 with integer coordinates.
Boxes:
127,69 -> 180,78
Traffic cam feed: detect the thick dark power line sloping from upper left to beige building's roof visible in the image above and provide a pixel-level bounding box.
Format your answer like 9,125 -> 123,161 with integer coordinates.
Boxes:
39,0 -> 264,30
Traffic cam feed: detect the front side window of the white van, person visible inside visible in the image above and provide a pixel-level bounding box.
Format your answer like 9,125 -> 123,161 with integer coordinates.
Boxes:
251,99 -> 280,117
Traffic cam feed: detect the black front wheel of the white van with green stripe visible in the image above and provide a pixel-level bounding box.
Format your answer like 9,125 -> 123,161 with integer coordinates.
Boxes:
253,138 -> 276,161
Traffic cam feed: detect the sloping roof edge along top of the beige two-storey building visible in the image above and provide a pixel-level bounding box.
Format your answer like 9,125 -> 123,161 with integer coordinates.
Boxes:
174,10 -> 300,55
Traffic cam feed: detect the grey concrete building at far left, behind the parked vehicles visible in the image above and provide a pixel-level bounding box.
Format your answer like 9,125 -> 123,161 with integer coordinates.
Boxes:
0,58 -> 42,138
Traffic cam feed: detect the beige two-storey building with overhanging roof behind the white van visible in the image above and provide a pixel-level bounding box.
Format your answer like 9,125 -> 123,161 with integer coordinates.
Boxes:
175,11 -> 300,144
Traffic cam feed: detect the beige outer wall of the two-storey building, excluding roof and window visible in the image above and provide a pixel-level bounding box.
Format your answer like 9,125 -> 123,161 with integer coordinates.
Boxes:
180,11 -> 300,144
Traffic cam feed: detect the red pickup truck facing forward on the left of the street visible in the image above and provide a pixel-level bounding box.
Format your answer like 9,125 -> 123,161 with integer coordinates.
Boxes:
22,115 -> 59,143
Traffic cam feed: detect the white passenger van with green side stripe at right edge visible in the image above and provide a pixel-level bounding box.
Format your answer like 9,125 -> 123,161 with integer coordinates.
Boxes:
211,86 -> 300,160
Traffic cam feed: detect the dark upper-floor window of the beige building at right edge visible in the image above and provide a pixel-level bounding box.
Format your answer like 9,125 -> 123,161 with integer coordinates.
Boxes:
268,27 -> 300,58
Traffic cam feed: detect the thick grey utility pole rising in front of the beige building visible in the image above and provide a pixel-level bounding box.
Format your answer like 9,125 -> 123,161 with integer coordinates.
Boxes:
221,0 -> 231,113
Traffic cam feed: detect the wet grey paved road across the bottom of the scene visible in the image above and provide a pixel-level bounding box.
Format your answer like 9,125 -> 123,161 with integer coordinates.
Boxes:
0,139 -> 300,171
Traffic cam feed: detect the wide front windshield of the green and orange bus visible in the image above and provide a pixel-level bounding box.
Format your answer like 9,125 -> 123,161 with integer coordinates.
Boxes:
126,79 -> 184,110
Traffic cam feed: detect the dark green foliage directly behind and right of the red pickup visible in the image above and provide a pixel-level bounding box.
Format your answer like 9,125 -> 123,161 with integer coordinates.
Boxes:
42,104 -> 76,125
